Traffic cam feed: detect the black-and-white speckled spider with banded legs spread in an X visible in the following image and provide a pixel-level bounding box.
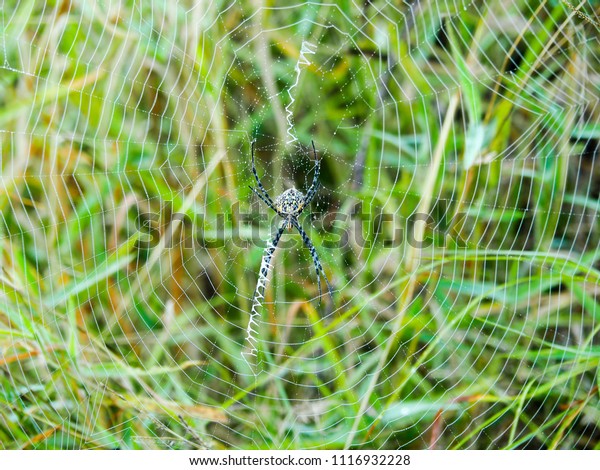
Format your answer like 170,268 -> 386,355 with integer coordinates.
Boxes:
250,141 -> 333,303
